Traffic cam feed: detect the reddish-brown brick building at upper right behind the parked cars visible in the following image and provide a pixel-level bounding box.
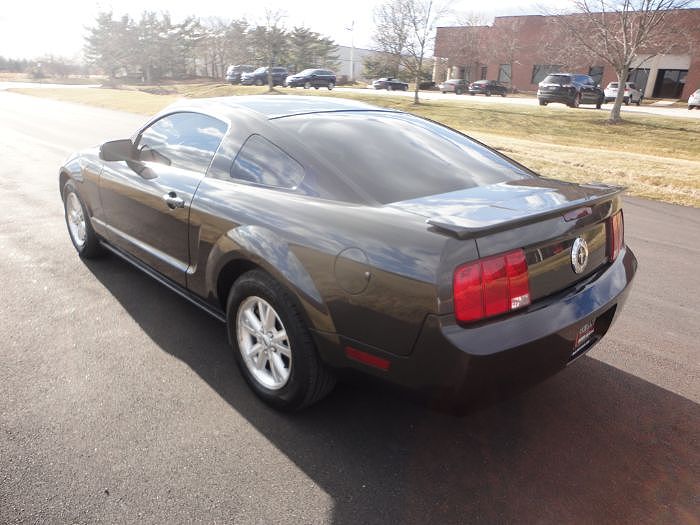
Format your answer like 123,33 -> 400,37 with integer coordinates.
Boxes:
433,9 -> 700,99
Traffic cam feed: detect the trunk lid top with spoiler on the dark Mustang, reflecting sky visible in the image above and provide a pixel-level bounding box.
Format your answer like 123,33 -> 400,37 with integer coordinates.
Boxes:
387,177 -> 622,236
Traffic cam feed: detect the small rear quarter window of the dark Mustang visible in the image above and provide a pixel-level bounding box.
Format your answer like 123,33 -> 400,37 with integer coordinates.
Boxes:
231,135 -> 304,190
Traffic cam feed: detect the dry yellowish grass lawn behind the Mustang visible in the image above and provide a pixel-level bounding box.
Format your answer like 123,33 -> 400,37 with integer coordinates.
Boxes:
10,84 -> 700,207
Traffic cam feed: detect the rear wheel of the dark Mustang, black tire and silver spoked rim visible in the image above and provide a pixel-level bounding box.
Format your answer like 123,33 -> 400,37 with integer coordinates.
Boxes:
226,270 -> 335,411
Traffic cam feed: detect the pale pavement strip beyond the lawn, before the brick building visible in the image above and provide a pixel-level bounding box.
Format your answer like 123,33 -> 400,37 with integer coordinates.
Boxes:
335,87 -> 700,119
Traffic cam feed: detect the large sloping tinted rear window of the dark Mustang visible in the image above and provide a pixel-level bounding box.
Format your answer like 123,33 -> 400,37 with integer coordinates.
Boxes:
276,111 -> 533,204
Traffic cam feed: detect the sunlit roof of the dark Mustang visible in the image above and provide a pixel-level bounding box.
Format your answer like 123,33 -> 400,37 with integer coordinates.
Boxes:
168,95 -> 396,119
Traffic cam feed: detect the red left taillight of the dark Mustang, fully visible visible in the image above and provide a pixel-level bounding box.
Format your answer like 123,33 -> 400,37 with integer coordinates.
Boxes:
453,249 -> 530,323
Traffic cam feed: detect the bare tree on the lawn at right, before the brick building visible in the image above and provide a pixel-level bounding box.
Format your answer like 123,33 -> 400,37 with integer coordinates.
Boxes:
556,0 -> 690,124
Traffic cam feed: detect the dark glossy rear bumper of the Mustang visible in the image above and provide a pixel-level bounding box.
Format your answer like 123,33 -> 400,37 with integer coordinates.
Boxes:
316,248 -> 637,402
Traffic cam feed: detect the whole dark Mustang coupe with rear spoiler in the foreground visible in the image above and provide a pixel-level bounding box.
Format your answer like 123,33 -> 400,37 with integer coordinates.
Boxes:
59,96 -> 637,410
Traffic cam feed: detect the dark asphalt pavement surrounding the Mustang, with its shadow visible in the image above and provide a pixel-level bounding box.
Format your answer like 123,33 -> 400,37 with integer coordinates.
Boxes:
0,93 -> 700,524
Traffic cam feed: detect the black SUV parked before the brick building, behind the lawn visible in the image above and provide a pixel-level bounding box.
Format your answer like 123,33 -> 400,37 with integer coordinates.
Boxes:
537,73 -> 605,109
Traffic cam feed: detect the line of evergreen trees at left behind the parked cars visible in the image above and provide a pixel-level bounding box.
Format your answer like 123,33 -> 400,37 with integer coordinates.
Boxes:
84,11 -> 338,83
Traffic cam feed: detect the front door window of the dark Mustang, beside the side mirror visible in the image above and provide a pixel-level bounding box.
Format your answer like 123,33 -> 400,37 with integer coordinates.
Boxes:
136,112 -> 227,174
